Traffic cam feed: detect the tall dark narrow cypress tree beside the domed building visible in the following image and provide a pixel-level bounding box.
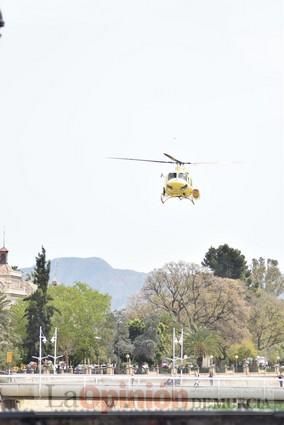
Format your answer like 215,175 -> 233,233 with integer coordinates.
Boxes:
24,247 -> 55,362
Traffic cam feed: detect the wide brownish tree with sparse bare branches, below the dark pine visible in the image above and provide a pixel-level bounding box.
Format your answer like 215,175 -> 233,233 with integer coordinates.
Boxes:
142,262 -> 249,341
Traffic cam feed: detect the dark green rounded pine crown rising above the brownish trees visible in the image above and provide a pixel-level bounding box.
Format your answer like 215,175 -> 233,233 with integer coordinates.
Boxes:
202,244 -> 248,279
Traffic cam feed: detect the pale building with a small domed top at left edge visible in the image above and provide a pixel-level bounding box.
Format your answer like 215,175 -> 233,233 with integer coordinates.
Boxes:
0,246 -> 37,304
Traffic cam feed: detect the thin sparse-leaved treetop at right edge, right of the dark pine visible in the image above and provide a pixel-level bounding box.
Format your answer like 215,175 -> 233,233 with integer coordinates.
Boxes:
247,257 -> 284,296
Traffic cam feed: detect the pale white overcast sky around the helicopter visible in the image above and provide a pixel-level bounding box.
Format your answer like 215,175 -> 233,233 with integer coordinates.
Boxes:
0,0 -> 284,272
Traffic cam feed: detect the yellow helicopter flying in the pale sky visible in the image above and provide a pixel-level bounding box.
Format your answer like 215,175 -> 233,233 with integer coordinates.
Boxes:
109,153 -> 204,204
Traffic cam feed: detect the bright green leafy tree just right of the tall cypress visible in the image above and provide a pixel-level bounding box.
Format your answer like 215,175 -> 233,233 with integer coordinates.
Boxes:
48,282 -> 111,365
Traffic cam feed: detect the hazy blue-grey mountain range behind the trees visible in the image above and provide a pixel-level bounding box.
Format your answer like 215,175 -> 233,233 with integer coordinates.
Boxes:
22,257 -> 147,310
